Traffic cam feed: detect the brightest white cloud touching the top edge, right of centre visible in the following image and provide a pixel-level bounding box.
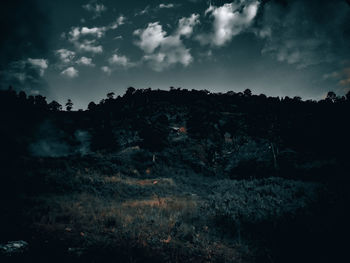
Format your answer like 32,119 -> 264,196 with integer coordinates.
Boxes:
197,1 -> 260,46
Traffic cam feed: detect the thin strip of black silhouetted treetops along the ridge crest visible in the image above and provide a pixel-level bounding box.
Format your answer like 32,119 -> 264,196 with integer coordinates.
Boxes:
0,86 -> 350,111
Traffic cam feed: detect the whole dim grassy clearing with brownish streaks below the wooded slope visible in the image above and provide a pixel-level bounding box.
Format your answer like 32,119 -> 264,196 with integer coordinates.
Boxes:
1,153 -> 340,262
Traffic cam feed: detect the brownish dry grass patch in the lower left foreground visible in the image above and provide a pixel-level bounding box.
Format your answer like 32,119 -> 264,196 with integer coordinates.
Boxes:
28,193 -> 247,262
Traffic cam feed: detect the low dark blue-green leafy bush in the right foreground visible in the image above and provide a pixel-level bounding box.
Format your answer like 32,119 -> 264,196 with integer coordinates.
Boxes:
210,178 -> 319,233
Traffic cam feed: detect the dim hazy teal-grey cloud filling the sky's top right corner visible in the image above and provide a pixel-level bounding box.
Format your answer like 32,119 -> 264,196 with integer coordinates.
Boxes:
256,0 -> 350,68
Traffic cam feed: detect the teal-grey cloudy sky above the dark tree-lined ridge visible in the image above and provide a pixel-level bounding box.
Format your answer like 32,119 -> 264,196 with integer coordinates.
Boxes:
0,0 -> 350,109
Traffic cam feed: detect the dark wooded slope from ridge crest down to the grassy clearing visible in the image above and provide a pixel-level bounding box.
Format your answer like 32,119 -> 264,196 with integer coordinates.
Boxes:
0,87 -> 350,169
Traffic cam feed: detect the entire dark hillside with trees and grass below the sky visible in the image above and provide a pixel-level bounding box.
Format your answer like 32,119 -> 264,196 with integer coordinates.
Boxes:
0,88 -> 350,262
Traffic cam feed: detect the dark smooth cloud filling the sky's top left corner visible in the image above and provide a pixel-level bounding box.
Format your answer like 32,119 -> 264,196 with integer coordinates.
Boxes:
0,0 -> 51,67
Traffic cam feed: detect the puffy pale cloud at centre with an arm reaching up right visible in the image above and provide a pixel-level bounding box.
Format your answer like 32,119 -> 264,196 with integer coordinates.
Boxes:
134,14 -> 199,71
